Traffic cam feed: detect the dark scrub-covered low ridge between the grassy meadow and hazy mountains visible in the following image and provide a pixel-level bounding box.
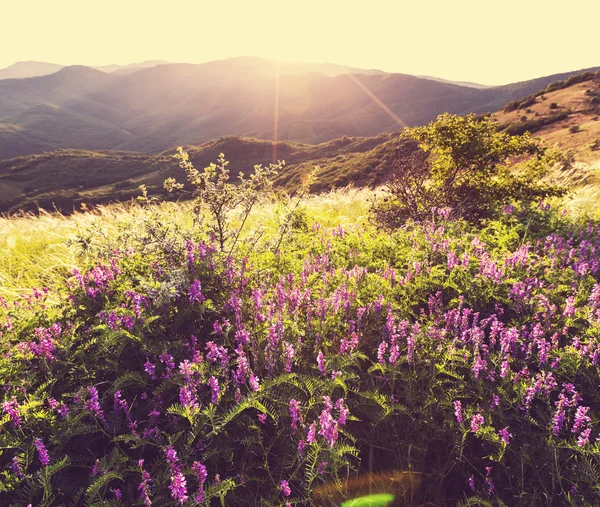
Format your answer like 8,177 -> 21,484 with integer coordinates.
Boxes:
0,134 -> 398,212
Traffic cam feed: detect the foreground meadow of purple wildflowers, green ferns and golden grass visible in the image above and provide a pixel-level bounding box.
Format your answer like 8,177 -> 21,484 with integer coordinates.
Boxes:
0,117 -> 600,506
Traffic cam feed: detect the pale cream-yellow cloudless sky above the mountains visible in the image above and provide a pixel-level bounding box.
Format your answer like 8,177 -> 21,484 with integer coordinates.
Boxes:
0,0 -> 600,84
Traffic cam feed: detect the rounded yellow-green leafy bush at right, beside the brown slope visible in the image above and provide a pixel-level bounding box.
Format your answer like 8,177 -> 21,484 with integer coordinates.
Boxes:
372,113 -> 564,227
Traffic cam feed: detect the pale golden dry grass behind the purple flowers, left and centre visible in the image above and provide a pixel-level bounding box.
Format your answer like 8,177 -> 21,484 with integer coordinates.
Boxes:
0,188 -> 375,297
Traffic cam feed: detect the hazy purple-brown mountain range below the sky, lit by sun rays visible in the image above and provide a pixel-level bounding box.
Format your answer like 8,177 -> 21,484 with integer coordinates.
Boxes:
0,57 -> 596,159
